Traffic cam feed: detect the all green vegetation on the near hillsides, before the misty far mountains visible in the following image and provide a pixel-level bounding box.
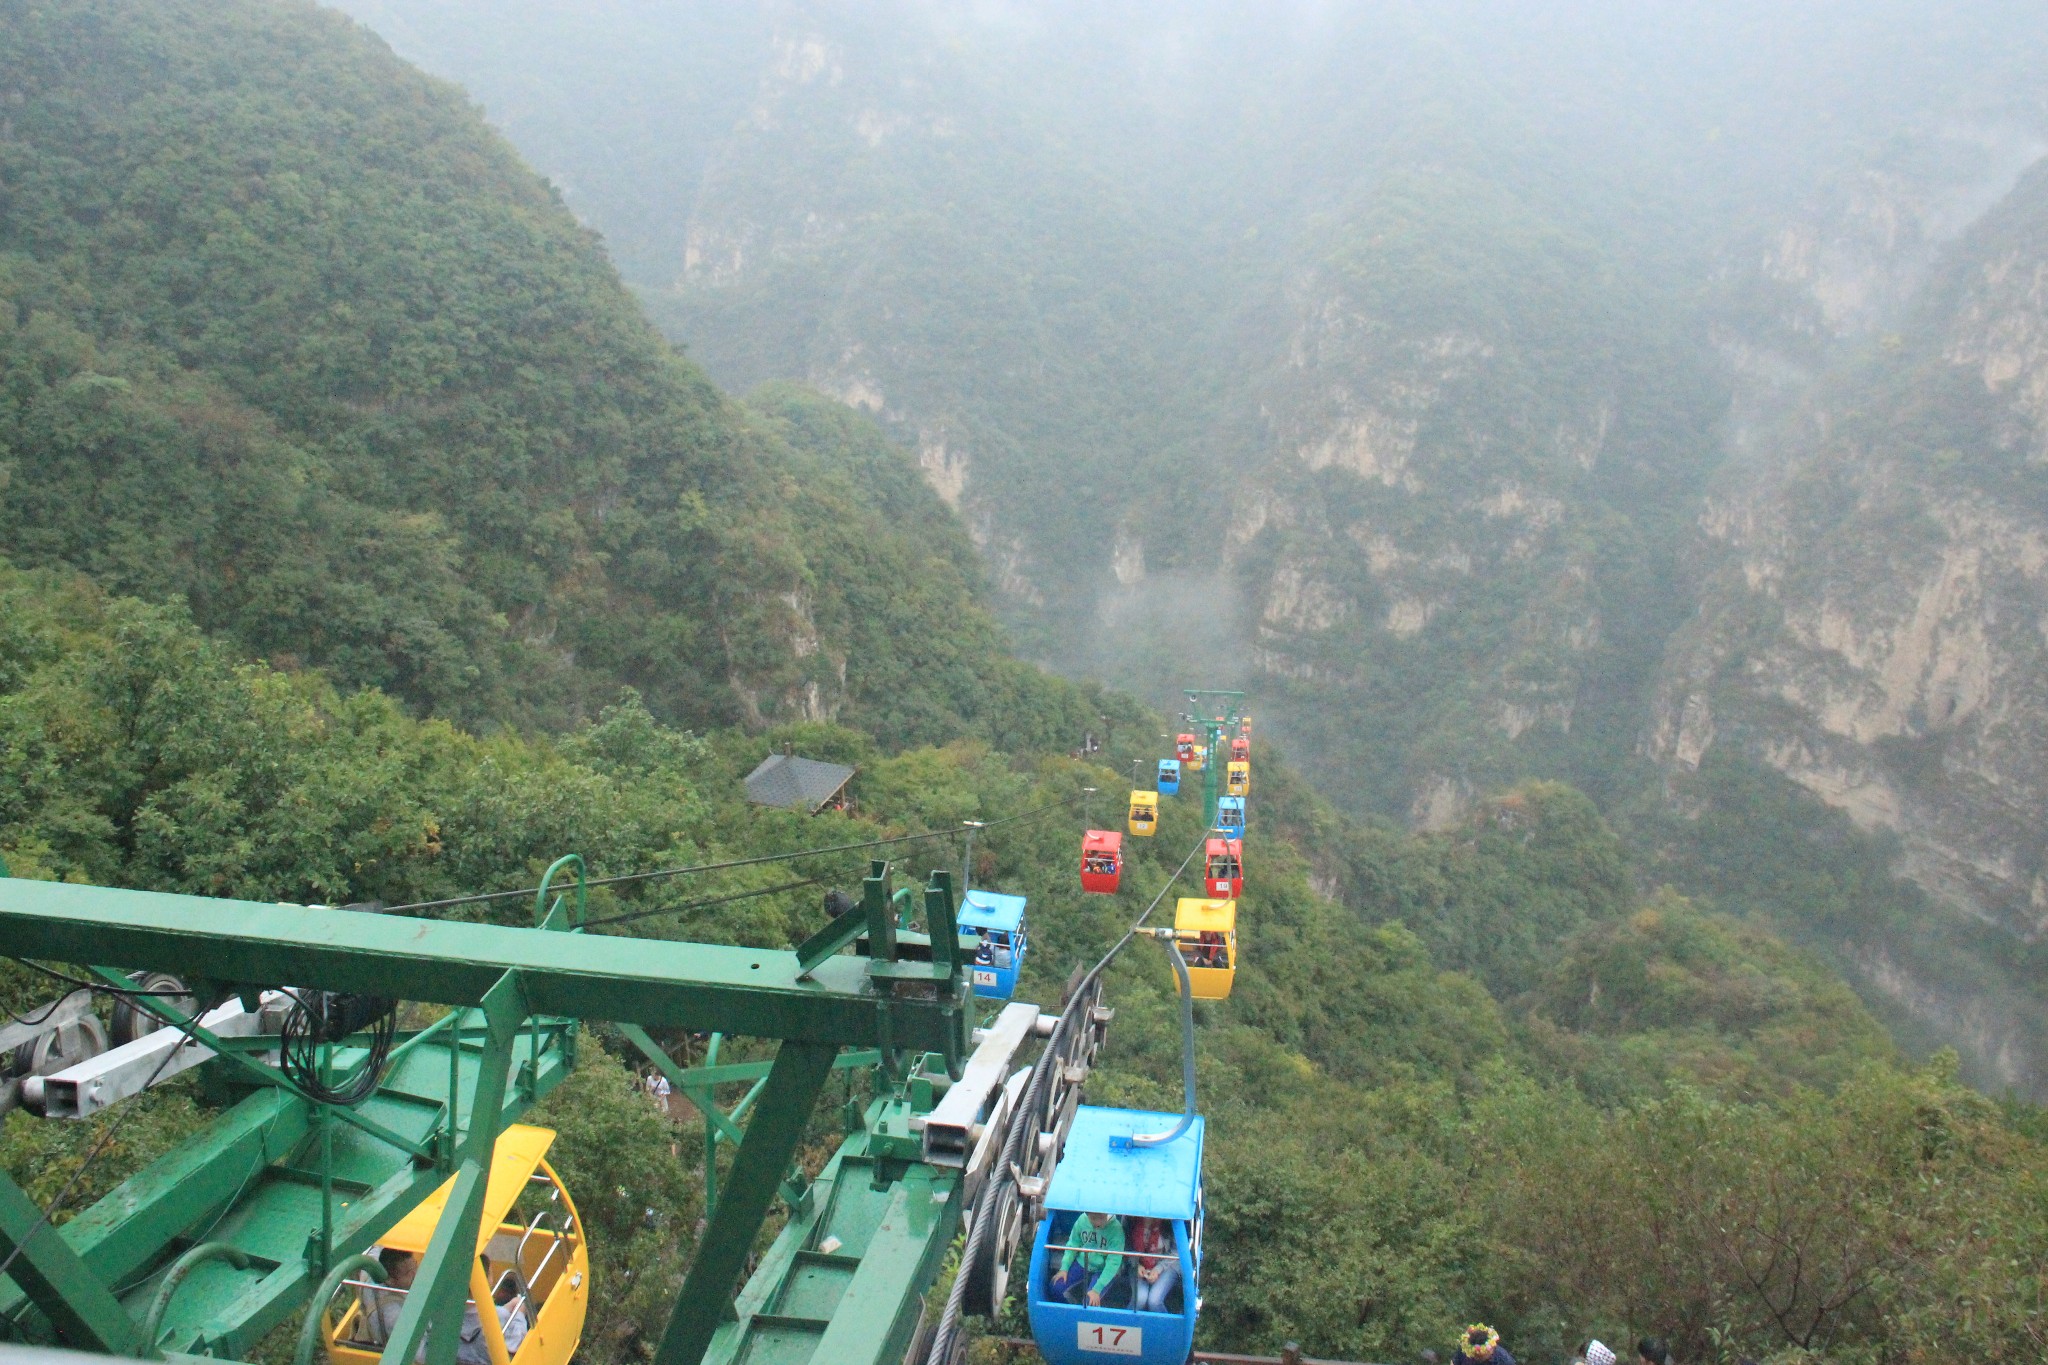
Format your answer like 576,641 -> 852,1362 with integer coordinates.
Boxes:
0,0 -> 2048,1365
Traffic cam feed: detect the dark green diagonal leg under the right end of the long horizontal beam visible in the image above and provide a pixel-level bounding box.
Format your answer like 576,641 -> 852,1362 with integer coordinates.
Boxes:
651,1042 -> 836,1365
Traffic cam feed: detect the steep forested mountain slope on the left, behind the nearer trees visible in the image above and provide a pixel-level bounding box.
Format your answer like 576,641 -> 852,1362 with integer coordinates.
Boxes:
0,0 -> 1092,741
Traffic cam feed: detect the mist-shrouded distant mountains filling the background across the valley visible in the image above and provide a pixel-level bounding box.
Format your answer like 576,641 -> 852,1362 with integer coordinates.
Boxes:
323,0 -> 2048,1087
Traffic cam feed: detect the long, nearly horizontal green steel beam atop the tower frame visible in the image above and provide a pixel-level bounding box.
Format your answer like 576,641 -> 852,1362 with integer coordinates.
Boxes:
0,874 -> 973,1052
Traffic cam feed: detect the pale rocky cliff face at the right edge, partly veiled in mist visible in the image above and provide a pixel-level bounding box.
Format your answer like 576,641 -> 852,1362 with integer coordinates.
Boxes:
1645,139 -> 2048,1085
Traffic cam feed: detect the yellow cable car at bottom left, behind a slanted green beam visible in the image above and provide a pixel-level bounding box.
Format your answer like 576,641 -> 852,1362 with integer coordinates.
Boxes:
322,1124 -> 590,1365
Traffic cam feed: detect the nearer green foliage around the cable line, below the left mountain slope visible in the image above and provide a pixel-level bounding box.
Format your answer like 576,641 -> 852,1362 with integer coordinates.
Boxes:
0,556 -> 2048,1363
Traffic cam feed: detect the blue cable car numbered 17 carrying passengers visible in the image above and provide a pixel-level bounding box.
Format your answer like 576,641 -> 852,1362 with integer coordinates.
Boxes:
1028,1105 -> 1202,1365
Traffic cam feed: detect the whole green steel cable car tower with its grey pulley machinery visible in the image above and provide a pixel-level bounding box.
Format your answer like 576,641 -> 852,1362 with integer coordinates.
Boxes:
0,855 -> 1108,1365
